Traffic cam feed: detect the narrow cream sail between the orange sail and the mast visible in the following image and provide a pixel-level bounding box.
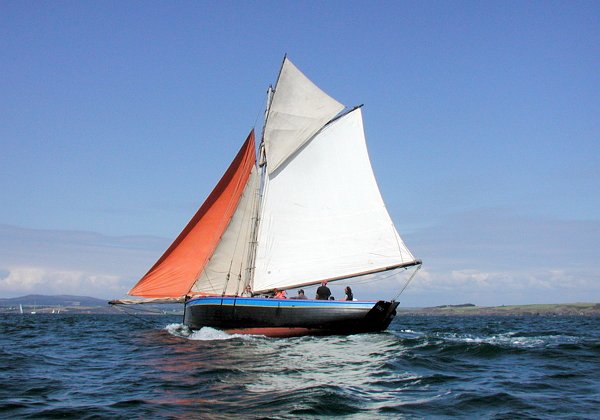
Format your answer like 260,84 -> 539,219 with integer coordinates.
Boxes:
191,168 -> 258,295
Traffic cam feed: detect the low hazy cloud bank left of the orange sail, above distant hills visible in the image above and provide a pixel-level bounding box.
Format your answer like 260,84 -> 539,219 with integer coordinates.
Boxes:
0,226 -> 168,299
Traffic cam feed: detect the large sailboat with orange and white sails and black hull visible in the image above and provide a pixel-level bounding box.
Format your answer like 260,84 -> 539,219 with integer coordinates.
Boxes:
110,57 -> 421,336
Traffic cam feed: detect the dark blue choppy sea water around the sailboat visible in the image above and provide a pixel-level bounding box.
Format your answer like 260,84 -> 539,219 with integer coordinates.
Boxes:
0,314 -> 600,419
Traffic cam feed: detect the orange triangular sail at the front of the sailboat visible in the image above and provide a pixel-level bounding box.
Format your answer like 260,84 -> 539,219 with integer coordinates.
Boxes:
129,130 -> 256,298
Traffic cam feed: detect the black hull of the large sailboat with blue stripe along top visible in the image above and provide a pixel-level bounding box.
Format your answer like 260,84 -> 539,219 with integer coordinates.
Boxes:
184,297 -> 398,336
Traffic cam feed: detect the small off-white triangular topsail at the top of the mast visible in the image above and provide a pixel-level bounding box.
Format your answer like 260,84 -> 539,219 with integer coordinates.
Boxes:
264,58 -> 344,173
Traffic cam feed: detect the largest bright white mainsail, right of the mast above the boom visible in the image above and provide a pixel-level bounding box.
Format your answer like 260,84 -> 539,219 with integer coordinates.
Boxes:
254,109 -> 415,291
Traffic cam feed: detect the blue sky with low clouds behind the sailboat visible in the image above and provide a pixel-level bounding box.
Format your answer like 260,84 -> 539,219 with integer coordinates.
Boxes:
0,0 -> 600,306
